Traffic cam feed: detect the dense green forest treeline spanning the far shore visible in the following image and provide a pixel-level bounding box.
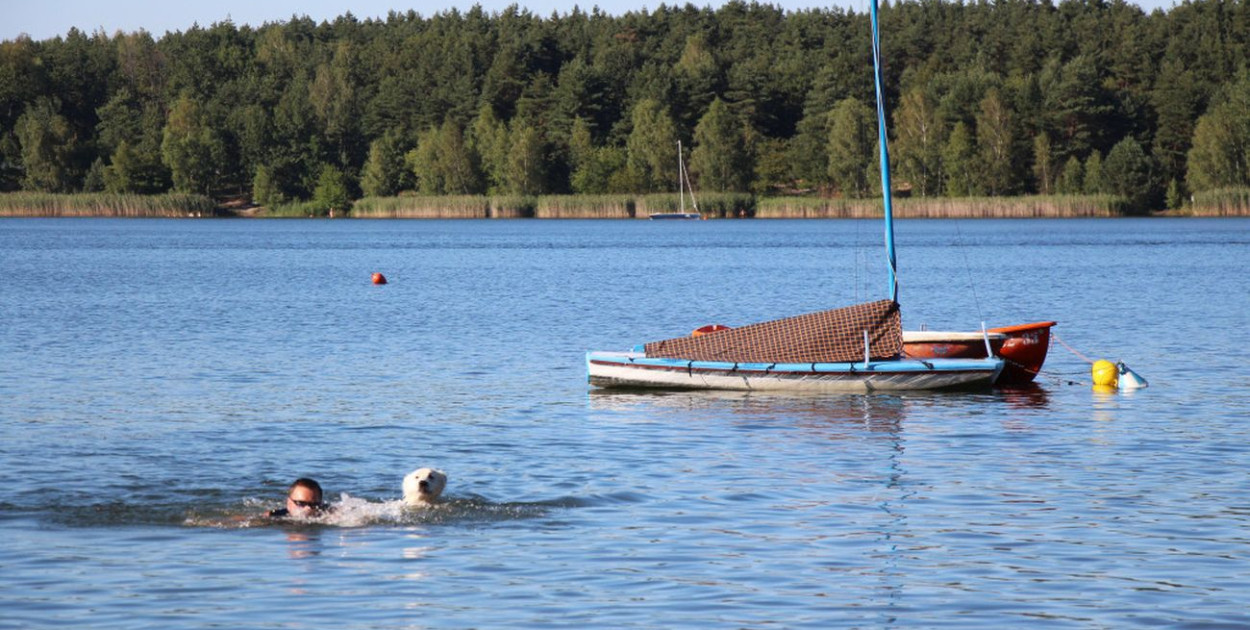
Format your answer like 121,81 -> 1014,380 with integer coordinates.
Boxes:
0,0 -> 1250,209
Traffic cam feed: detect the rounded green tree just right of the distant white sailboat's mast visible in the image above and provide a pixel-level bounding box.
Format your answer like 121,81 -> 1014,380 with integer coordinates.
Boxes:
690,99 -> 753,191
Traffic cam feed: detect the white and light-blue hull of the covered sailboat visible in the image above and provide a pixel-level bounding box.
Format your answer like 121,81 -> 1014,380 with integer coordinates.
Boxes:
586,353 -> 1003,394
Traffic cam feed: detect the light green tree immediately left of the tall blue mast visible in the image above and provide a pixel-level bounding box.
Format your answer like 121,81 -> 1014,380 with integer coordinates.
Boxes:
829,98 -> 876,198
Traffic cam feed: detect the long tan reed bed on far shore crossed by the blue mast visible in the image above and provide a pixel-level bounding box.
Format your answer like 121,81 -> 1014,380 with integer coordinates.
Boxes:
755,195 -> 1130,219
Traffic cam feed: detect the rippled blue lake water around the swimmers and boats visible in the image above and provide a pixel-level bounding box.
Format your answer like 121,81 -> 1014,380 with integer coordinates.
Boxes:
0,219 -> 1250,629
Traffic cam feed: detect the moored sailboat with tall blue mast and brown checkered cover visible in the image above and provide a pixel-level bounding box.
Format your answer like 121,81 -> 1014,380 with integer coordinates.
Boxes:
586,0 -> 1004,393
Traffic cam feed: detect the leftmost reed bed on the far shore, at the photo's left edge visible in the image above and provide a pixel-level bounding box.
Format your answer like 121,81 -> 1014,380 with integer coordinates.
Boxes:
0,193 -> 223,218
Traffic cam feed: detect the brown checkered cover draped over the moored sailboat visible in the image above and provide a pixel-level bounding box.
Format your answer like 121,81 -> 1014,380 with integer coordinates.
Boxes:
645,300 -> 903,363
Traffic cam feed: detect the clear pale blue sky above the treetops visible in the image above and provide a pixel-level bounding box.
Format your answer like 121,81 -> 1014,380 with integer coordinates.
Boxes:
7,0 -> 1174,40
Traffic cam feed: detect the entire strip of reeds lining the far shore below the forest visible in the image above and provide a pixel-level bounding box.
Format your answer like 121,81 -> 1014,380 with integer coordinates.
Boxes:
0,189 -> 1250,219
